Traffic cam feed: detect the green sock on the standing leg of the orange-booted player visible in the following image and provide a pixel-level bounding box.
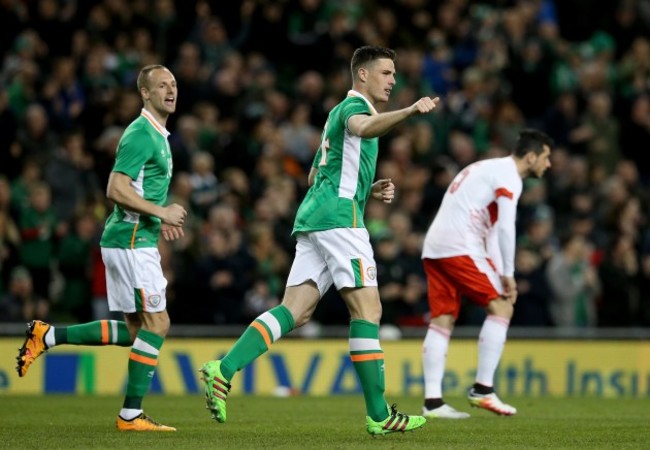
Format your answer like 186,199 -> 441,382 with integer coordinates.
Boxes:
123,329 -> 165,409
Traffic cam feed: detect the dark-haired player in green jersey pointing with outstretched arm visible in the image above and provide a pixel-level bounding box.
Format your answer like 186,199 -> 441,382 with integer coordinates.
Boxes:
201,46 -> 439,435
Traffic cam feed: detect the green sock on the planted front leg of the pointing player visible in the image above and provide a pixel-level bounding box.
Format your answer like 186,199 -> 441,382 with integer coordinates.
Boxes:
350,320 -> 388,422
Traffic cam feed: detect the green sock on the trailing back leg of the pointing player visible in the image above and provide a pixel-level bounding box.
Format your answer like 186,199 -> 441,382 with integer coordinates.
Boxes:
221,305 -> 295,381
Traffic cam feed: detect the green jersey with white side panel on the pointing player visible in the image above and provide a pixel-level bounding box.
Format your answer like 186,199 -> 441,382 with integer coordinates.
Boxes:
293,91 -> 379,234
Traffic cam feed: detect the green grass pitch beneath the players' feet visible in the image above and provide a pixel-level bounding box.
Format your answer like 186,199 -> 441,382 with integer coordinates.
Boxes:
0,395 -> 650,450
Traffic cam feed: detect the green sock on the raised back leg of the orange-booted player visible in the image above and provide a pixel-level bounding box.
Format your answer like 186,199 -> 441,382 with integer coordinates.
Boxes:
54,320 -> 133,347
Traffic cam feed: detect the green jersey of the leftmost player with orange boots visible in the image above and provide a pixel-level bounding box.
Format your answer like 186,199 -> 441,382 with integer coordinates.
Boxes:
100,109 -> 173,248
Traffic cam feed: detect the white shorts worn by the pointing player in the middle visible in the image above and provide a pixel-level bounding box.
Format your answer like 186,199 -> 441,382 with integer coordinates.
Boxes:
287,228 -> 377,297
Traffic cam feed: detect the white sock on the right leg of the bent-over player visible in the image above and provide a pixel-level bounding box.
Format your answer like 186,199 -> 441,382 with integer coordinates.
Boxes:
476,315 -> 510,387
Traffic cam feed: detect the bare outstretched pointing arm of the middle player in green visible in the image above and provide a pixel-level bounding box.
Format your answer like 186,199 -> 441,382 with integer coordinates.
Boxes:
348,97 -> 440,138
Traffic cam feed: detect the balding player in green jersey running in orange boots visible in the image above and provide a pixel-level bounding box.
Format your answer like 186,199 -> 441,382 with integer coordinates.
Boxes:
17,65 -> 187,431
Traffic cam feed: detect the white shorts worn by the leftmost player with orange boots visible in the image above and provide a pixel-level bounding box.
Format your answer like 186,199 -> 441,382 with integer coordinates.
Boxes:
102,247 -> 167,313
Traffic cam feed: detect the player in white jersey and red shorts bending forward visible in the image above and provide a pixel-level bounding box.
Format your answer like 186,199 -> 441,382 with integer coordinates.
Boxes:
422,130 -> 553,419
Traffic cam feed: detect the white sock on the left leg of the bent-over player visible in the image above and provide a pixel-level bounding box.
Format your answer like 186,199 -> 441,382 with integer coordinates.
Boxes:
422,325 -> 451,398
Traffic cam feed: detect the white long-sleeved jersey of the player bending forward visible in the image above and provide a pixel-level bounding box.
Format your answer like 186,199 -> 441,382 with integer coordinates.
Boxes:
422,156 -> 523,276
